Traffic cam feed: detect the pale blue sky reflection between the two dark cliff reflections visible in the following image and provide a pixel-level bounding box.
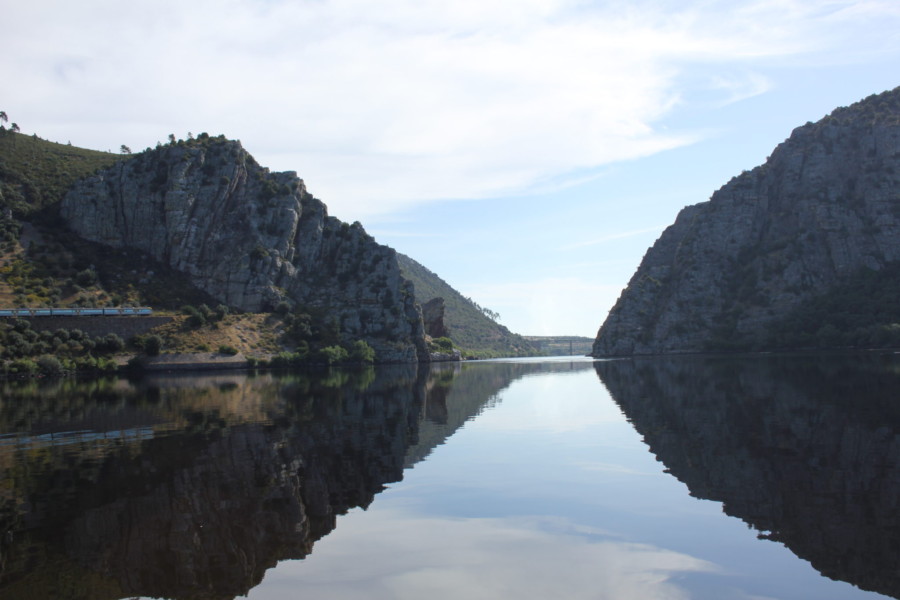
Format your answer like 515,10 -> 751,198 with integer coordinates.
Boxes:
249,370 -> 879,600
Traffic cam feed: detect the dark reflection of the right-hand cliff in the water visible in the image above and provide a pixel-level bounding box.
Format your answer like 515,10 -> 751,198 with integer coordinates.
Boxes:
596,355 -> 900,597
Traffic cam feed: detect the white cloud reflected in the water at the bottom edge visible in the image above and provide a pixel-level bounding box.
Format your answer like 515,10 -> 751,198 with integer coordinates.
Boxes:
249,511 -> 718,600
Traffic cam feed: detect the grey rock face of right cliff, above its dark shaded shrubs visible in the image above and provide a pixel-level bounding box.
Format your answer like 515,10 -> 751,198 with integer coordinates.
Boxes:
593,88 -> 900,356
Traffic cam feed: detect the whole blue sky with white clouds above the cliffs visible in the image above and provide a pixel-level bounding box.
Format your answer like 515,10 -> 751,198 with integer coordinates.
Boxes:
0,0 -> 900,337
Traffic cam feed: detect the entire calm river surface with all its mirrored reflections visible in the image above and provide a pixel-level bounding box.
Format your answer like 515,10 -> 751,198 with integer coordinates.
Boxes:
0,354 -> 900,600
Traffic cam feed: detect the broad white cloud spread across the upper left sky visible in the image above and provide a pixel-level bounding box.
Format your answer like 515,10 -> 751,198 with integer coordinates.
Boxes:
0,0 -> 900,220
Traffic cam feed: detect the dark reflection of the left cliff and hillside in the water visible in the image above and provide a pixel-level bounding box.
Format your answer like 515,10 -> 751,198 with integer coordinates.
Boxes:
0,363 -> 590,599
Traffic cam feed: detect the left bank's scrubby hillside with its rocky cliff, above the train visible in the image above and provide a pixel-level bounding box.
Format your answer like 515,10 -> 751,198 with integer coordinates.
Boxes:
0,130 -> 427,362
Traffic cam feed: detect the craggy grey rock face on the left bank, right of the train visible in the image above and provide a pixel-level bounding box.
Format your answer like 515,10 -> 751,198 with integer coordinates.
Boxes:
61,138 -> 427,361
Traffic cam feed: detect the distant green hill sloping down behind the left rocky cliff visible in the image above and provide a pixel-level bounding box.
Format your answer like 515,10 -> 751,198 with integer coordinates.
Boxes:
397,253 -> 537,358
